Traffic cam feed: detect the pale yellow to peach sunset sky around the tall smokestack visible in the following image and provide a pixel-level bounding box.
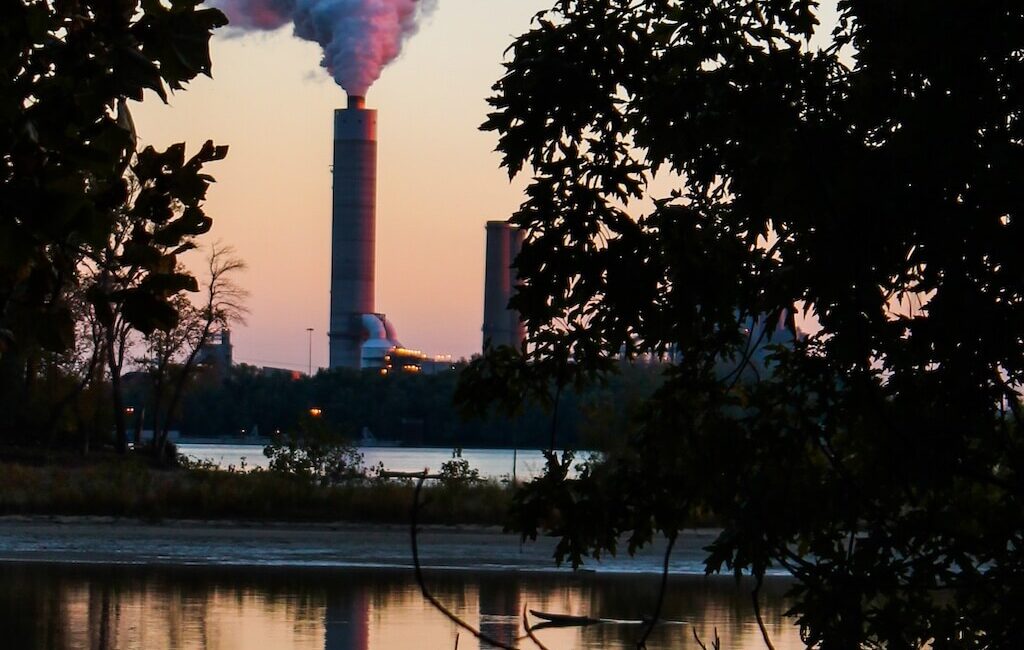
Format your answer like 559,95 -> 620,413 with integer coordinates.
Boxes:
132,0 -> 553,371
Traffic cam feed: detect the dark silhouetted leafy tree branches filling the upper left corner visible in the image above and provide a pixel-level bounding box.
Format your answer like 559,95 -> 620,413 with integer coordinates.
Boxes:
0,0 -> 226,446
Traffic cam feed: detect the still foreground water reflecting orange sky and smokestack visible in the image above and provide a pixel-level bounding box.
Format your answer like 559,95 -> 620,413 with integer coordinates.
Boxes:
0,564 -> 802,650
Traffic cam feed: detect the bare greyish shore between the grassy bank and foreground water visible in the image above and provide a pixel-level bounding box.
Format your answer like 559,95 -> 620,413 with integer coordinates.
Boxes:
0,517 -> 733,574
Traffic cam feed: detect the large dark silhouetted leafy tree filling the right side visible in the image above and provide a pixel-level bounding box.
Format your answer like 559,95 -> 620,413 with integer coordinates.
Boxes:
462,0 -> 1024,648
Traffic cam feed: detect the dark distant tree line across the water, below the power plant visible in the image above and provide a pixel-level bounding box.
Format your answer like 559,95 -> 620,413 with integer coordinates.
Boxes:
126,363 -> 662,449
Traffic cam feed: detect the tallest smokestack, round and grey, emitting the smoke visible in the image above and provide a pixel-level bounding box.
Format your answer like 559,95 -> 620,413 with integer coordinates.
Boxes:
328,96 -> 377,369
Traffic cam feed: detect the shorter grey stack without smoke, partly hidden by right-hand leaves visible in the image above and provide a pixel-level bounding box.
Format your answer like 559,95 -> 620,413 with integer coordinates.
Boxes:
483,221 -> 526,350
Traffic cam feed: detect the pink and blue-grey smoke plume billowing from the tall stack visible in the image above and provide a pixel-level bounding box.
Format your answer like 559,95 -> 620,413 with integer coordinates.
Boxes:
217,0 -> 437,96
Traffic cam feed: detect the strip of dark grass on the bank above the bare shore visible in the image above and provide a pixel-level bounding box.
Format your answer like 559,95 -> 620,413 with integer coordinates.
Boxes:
0,459 -> 512,525
